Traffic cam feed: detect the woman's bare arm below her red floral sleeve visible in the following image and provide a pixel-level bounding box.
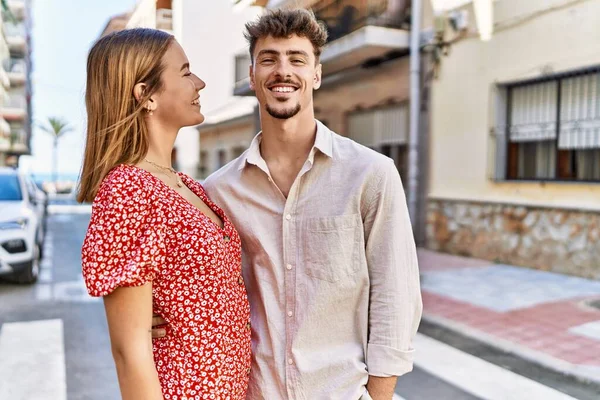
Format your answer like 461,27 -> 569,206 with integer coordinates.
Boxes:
104,282 -> 163,400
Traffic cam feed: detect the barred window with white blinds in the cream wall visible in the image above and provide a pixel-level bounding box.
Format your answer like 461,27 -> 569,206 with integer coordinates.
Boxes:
496,70 -> 600,181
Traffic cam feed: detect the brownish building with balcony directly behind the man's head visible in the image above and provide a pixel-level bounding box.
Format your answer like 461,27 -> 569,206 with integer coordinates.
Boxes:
209,0 -> 432,241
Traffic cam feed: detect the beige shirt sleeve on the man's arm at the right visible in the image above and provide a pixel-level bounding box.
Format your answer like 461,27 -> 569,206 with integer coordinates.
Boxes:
364,160 -> 423,377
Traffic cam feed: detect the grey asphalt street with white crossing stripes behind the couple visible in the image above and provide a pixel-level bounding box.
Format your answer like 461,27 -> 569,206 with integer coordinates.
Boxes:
0,212 -> 599,400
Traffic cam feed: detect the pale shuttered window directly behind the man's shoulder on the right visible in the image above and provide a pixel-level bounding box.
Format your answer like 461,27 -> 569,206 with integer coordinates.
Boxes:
347,103 -> 409,180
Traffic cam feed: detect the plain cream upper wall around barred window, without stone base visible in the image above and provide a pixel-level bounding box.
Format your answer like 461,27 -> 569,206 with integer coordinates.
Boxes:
429,0 -> 600,210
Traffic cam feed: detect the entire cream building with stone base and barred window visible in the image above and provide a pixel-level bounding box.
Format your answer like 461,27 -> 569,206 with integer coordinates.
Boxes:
427,0 -> 600,279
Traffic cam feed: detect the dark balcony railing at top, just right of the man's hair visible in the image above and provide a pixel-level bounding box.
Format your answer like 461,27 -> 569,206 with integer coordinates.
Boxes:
312,0 -> 410,42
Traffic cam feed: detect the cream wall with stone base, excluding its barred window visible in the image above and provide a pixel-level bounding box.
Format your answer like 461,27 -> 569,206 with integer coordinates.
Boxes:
428,0 -> 600,277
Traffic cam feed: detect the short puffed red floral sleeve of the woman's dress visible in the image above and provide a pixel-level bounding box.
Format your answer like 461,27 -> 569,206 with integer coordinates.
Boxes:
81,172 -> 166,297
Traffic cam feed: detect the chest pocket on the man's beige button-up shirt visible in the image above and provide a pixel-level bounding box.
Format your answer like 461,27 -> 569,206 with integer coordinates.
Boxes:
305,214 -> 361,282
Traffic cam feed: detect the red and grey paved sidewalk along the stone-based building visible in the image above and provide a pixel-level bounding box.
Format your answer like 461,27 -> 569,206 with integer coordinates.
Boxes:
418,249 -> 600,383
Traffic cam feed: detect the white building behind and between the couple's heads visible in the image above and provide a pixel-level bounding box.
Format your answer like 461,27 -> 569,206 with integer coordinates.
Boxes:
103,0 -> 259,178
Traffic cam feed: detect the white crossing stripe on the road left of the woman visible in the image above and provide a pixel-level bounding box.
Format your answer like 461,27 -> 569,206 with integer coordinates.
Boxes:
0,319 -> 67,400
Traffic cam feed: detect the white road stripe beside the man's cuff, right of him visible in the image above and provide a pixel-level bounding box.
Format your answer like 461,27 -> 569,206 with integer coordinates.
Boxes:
415,334 -> 575,400
